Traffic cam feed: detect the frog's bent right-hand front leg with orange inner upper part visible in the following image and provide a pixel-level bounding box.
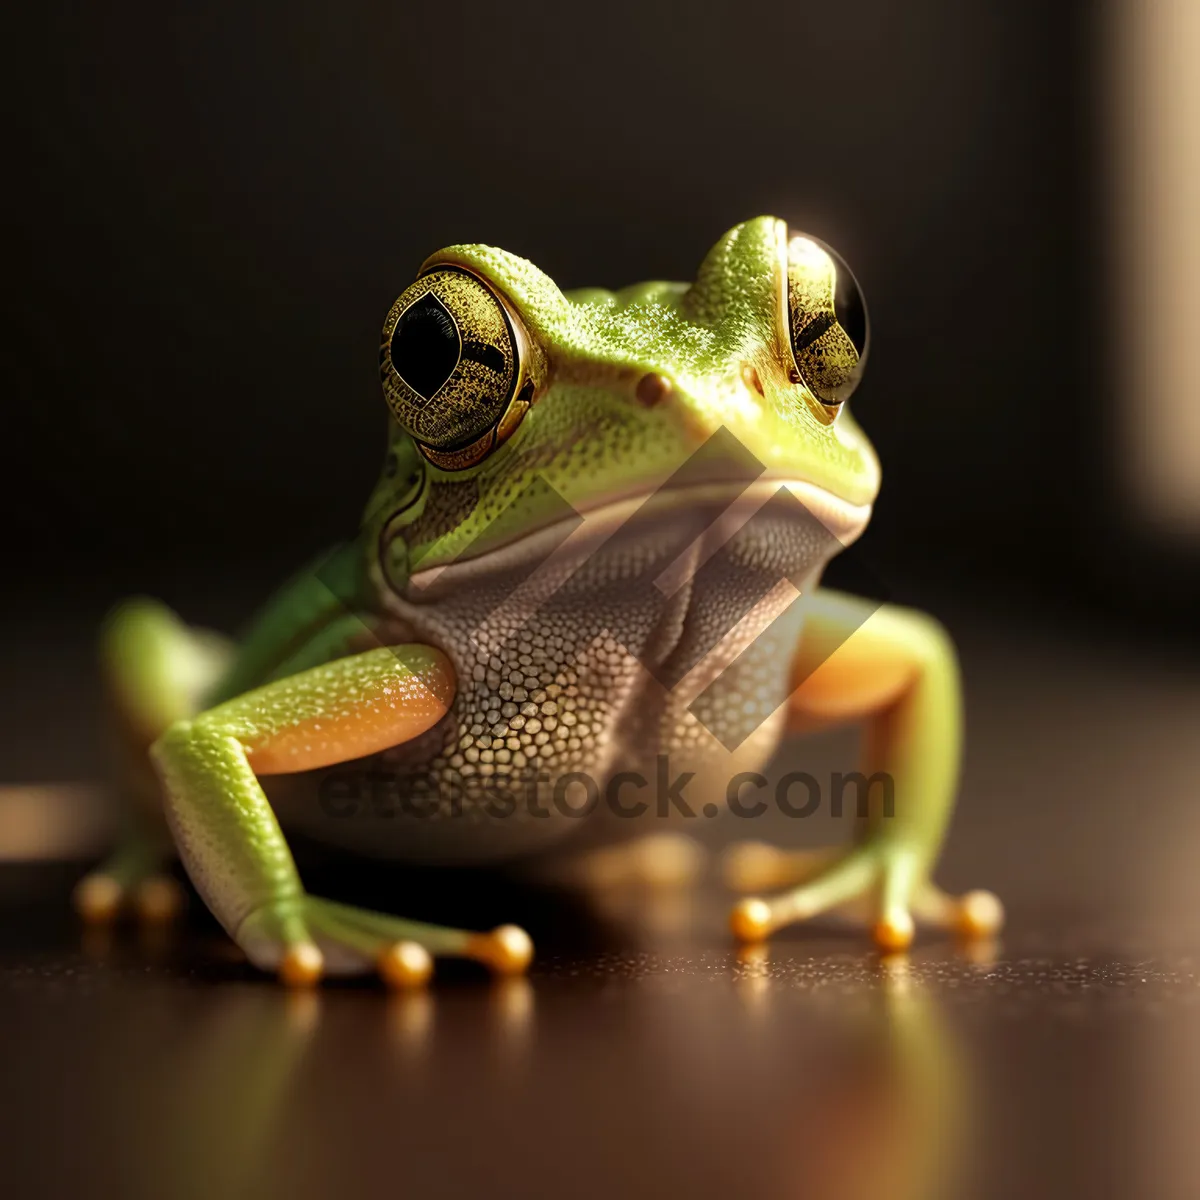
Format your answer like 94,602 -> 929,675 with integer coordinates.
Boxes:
732,590 -> 1003,949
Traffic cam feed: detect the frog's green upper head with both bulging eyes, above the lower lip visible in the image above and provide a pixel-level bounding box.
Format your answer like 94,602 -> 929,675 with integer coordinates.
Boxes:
368,217 -> 880,597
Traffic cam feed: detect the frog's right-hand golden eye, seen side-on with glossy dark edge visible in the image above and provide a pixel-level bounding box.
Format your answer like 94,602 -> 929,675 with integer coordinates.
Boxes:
787,234 -> 869,409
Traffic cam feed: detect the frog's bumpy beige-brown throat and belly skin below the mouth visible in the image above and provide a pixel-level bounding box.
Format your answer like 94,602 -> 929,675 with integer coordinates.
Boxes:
268,503 -> 836,863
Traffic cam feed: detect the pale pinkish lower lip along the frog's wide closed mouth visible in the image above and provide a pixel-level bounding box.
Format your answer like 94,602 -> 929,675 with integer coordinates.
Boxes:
407,478 -> 871,604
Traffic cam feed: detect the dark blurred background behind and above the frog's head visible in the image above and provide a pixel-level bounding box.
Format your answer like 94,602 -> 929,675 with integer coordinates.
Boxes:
4,0 -> 1152,622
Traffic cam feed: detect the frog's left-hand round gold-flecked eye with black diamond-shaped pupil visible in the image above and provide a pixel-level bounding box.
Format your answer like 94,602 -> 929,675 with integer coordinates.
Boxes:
379,266 -> 533,470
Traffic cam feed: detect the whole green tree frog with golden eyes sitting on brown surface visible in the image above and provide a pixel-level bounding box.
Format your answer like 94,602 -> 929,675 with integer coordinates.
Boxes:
76,216 -> 1003,988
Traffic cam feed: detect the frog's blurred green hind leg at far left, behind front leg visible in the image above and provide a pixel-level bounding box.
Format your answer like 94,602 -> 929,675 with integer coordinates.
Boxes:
74,599 -> 233,922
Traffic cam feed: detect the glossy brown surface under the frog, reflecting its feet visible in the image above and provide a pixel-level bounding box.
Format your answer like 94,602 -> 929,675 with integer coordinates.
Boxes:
0,630 -> 1200,1200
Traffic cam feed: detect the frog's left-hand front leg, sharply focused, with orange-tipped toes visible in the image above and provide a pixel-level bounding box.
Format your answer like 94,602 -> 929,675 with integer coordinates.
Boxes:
151,646 -> 532,985
